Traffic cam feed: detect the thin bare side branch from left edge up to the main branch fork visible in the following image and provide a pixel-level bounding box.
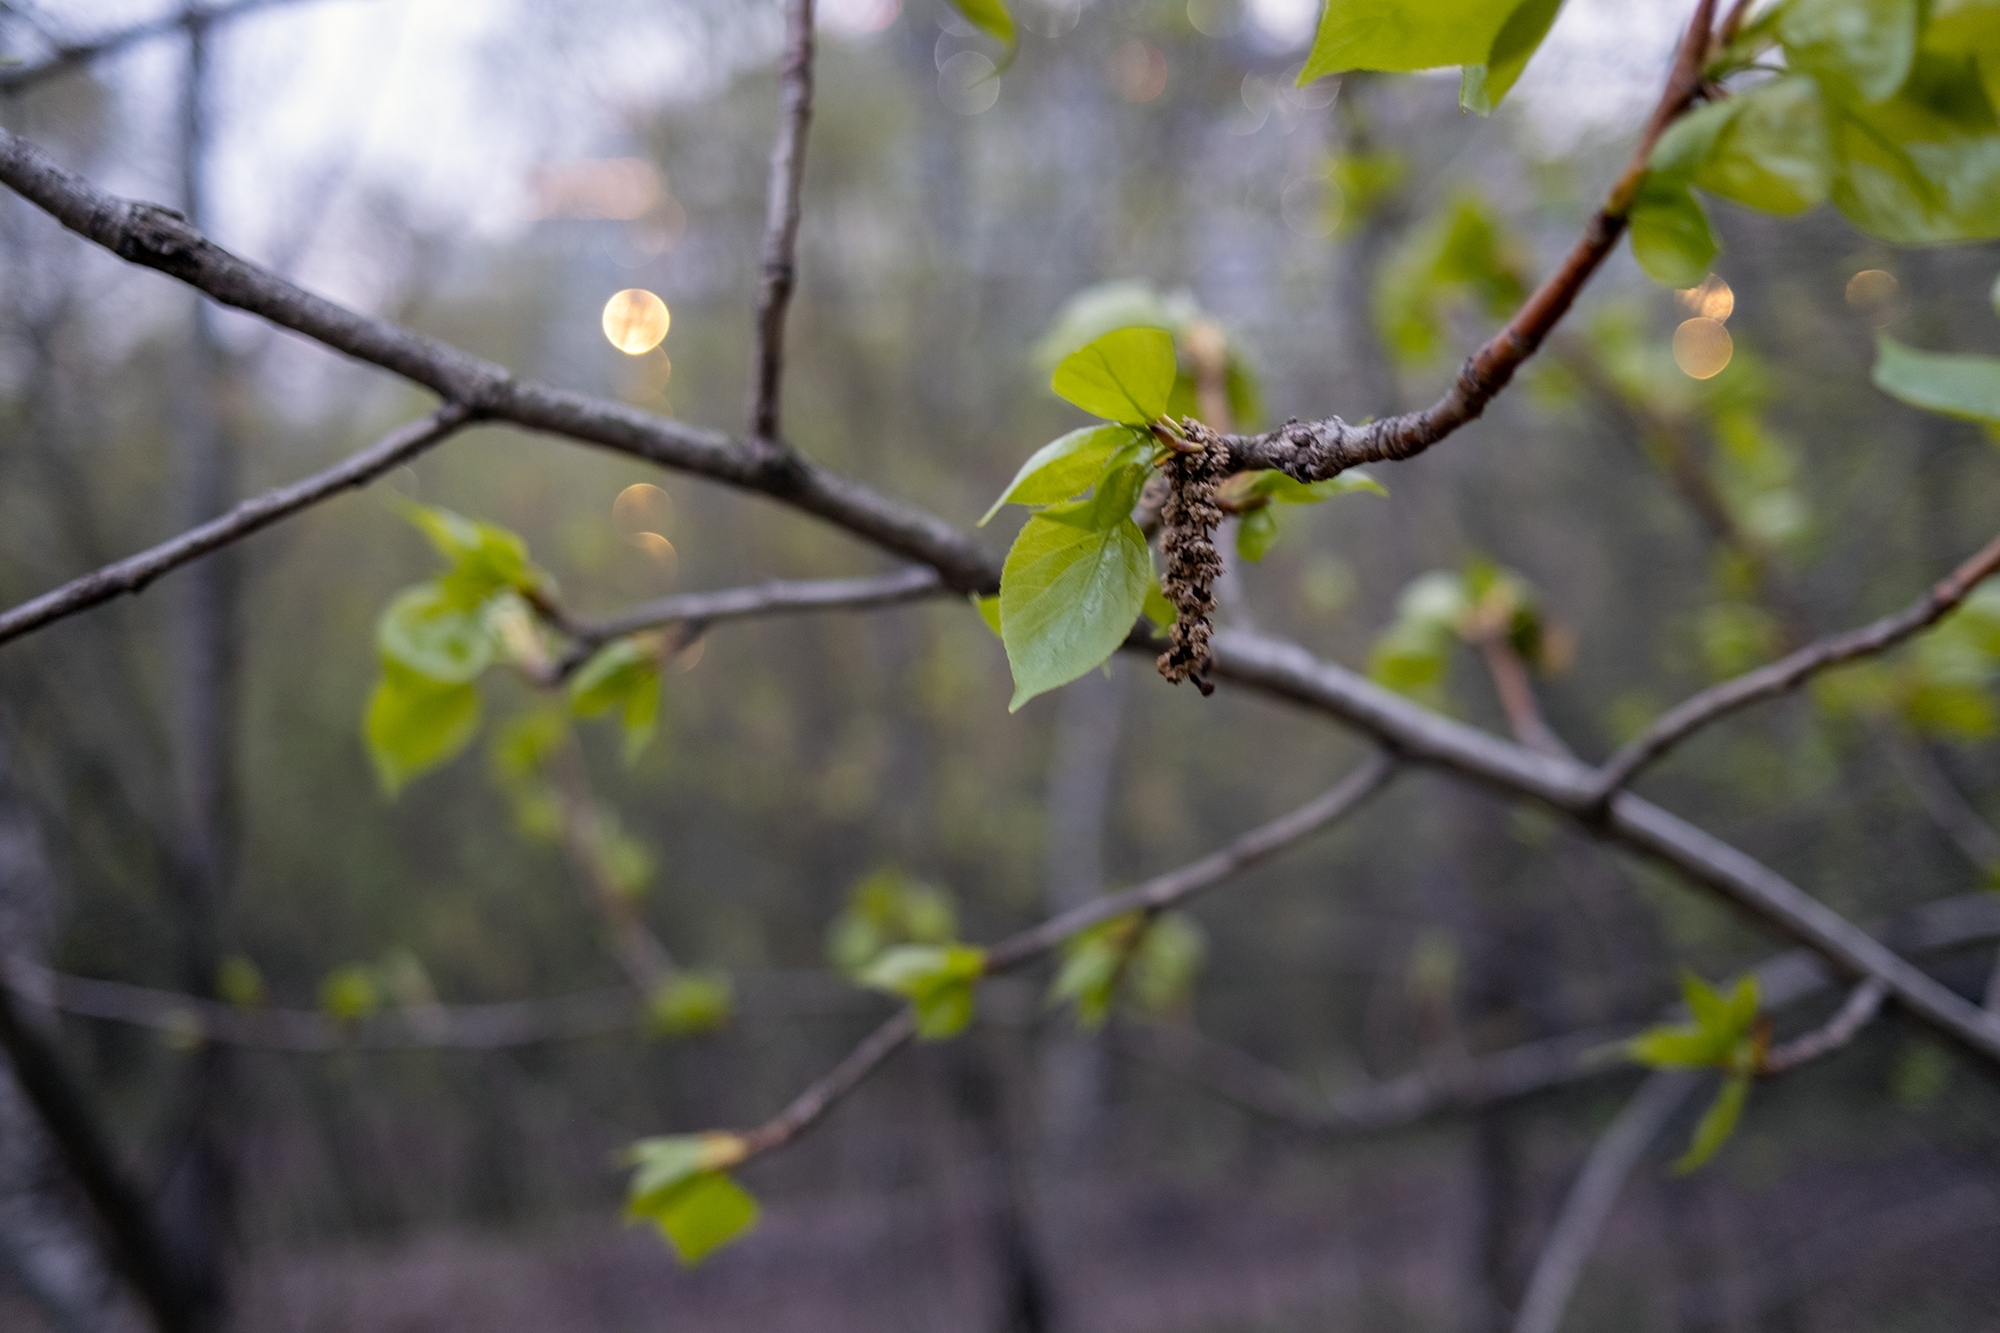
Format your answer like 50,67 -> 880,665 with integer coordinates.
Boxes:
0,404 -> 472,642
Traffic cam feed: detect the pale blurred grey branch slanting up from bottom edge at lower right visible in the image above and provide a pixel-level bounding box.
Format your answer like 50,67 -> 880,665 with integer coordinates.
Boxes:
1514,1071 -> 1702,1333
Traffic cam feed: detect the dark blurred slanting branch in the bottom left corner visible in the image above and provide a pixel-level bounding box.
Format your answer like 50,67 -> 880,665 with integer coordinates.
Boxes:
0,972 -> 204,1333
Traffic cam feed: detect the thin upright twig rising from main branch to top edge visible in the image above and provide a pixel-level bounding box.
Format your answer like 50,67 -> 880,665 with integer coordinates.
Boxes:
750,0 -> 812,448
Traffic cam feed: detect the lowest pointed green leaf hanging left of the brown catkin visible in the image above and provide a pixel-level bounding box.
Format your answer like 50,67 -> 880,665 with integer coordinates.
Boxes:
1000,510 -> 1156,713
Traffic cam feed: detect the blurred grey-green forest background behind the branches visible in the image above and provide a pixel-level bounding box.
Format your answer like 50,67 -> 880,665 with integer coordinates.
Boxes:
0,0 -> 2000,1333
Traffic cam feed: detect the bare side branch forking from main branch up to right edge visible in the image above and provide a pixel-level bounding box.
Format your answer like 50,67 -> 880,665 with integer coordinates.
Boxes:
1592,536 -> 2000,801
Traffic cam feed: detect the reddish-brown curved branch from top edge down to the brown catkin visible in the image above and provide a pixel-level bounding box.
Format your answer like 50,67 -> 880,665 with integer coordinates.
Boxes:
1224,0 -> 1716,480
